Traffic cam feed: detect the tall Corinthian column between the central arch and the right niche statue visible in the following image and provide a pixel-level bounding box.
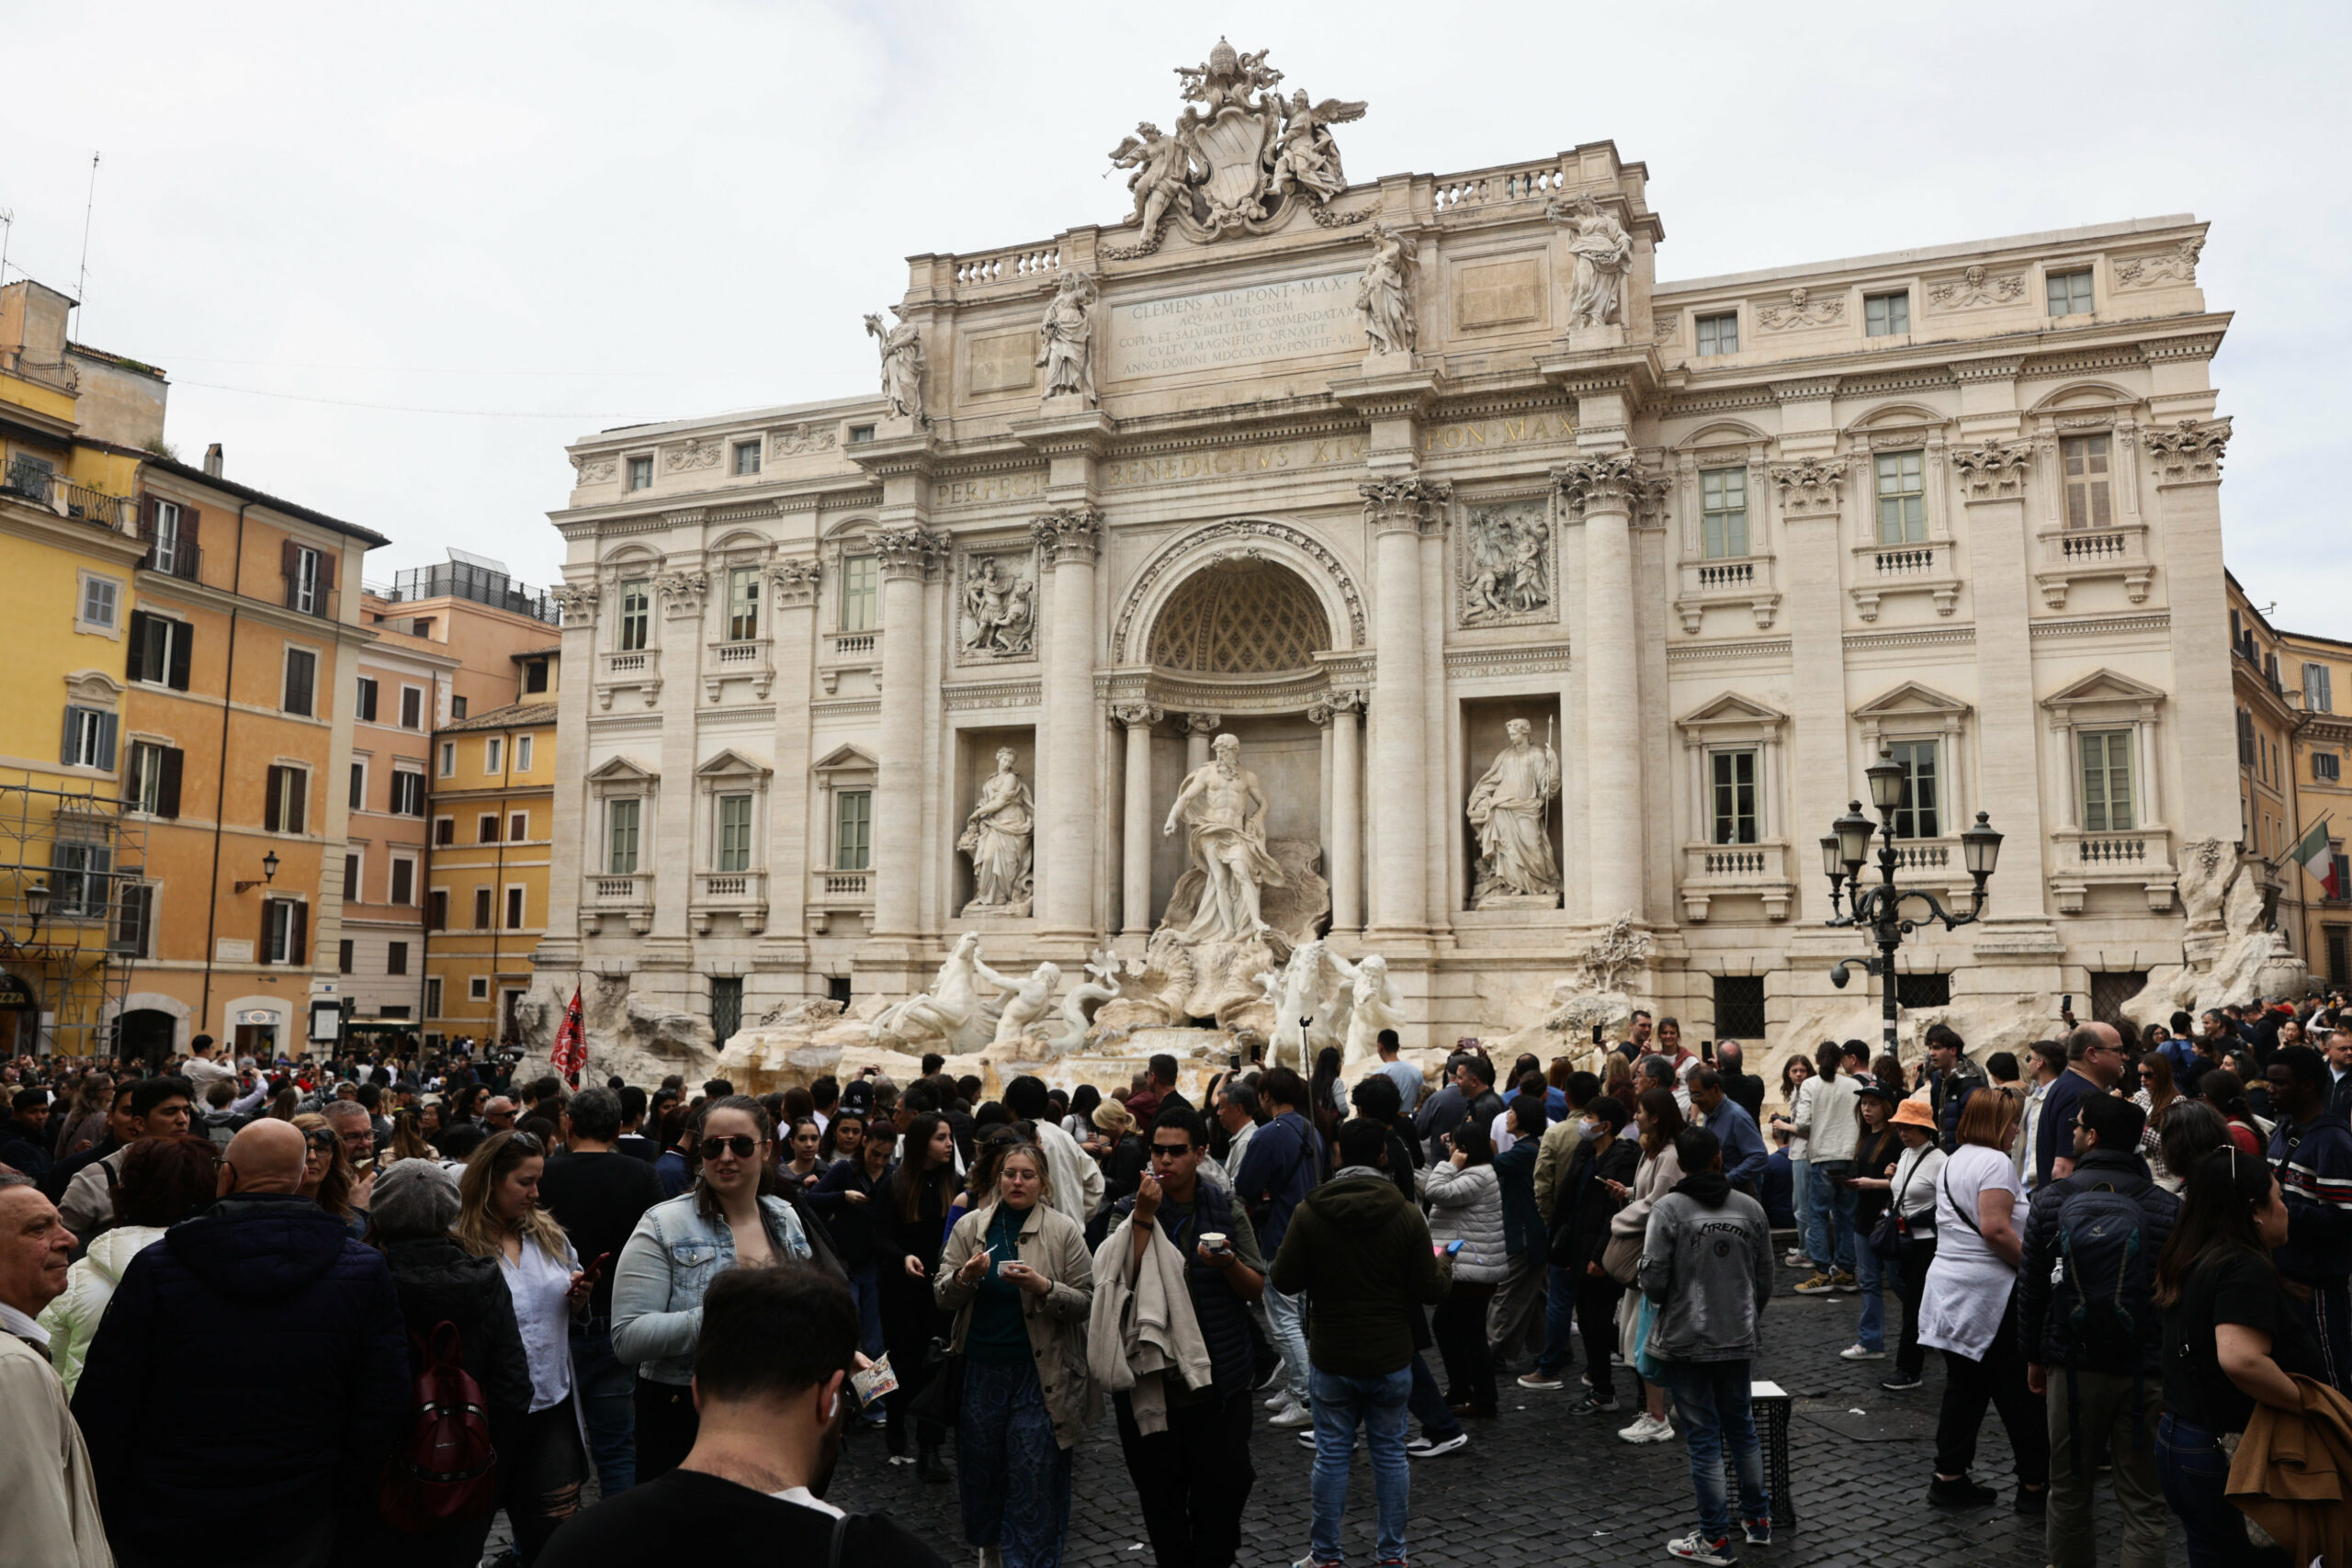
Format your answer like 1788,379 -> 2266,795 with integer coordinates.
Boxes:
1363,472 -> 1453,941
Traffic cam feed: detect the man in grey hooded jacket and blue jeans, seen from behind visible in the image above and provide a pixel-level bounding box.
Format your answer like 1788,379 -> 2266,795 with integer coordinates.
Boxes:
1642,1126 -> 1771,1563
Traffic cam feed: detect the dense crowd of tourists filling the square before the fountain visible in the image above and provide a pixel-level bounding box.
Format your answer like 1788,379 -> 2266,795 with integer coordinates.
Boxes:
0,999 -> 2352,1568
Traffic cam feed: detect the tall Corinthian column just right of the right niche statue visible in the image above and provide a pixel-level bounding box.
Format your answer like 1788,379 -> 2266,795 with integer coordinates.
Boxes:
1553,451 -> 1649,919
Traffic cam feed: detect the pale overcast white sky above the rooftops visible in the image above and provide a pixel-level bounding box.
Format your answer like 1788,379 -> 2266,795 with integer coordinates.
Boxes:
14,0 -> 2352,635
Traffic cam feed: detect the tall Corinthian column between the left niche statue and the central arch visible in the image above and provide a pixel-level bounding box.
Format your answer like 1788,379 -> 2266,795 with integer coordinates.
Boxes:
1030,505 -> 1103,941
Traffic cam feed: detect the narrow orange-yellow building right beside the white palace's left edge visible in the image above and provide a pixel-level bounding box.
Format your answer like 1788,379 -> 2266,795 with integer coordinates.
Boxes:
425,647 -> 560,1043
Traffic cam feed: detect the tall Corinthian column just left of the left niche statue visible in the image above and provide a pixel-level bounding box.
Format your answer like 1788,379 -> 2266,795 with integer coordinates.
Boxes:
873,526 -> 948,941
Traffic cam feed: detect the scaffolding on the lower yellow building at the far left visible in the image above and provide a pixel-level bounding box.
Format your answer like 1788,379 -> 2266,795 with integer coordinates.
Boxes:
0,778 -> 153,1055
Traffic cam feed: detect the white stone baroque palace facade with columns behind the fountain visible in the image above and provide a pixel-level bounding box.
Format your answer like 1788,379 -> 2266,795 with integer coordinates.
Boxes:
537,45 -> 2239,1046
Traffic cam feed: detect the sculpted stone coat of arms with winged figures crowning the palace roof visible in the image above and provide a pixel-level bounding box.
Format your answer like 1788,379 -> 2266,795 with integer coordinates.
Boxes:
1105,38 -> 1369,259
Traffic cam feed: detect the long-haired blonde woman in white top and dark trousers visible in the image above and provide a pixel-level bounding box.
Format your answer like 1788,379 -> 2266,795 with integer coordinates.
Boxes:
449,1134 -> 595,1563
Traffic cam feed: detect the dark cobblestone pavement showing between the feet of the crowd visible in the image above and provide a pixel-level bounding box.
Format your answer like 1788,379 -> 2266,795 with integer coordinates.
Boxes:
831,1269 -> 2188,1568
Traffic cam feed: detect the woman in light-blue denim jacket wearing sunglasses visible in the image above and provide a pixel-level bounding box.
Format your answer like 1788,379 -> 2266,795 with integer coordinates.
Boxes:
612,1096 -> 811,1481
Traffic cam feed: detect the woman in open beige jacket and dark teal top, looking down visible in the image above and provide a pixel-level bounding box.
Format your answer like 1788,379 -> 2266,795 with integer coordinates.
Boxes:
932,1143 -> 1101,1568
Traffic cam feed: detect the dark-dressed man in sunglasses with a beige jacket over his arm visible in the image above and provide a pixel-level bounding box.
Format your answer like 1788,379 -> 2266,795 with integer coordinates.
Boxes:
1110,1105 -> 1265,1568
